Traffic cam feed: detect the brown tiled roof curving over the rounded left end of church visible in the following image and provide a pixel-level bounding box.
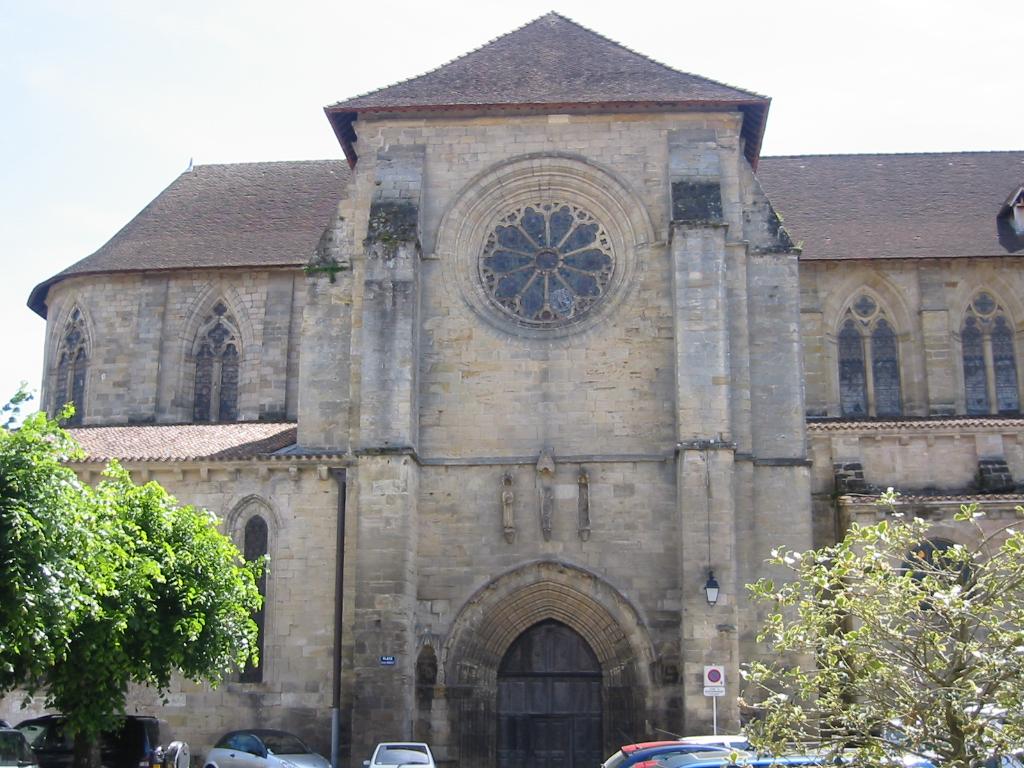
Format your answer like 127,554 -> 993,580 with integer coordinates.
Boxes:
29,160 -> 350,317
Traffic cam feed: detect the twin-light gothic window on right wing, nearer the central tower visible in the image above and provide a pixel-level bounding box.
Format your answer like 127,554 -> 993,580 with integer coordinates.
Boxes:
838,294 -> 902,418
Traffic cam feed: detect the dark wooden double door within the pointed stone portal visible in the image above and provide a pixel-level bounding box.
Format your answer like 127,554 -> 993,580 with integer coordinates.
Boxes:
498,622 -> 603,768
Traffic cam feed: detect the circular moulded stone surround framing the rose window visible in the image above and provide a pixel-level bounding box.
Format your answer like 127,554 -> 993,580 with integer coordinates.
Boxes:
435,154 -> 654,339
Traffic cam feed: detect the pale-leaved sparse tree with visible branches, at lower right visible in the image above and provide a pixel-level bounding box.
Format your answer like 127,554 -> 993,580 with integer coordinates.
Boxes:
745,490 -> 1024,768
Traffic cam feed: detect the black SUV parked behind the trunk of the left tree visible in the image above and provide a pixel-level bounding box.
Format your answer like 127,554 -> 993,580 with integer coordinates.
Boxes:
17,715 -> 167,768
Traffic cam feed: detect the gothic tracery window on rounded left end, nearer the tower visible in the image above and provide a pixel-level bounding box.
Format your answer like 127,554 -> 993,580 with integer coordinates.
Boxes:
193,301 -> 241,421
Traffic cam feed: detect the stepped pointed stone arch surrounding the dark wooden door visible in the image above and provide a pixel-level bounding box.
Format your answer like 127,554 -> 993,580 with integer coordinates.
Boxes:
438,561 -> 654,768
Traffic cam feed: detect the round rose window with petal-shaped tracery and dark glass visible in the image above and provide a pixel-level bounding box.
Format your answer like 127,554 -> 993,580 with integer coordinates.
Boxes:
479,203 -> 615,327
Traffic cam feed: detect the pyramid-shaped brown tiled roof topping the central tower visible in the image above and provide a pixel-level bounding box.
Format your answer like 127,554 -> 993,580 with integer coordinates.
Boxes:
325,13 -> 770,165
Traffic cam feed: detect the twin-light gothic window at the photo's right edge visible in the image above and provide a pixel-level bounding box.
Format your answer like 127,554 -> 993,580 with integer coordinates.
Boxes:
961,291 -> 1020,415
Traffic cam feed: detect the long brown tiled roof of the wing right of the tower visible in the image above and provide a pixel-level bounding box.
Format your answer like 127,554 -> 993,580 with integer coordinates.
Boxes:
758,152 -> 1024,260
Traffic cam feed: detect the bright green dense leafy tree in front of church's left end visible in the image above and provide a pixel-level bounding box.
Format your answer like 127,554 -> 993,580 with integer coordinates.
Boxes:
0,393 -> 262,761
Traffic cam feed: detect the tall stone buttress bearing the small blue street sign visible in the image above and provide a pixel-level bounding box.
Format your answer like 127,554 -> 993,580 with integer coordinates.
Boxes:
352,145 -> 425,756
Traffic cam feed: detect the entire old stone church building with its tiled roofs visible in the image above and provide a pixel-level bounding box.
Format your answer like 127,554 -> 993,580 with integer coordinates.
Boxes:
4,14 -> 1024,767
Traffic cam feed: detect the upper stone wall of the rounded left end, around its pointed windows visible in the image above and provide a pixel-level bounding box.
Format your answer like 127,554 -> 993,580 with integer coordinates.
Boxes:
43,270 -> 303,425
